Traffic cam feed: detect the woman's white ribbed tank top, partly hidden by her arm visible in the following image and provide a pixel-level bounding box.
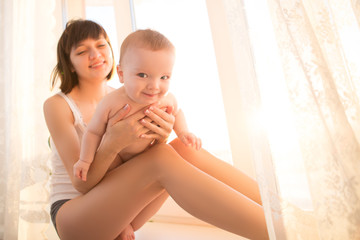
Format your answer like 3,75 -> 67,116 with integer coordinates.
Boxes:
50,92 -> 86,204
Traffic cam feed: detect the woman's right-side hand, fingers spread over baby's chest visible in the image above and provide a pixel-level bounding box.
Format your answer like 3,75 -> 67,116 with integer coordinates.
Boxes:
140,106 -> 175,142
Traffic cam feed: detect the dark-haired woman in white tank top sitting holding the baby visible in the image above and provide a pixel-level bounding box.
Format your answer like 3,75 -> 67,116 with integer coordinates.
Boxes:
44,20 -> 268,240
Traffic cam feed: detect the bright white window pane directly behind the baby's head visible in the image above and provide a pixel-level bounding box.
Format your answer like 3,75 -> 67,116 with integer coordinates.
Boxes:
134,0 -> 232,162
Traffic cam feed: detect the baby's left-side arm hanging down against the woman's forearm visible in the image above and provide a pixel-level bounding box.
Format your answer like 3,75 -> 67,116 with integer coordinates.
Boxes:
74,101 -> 109,181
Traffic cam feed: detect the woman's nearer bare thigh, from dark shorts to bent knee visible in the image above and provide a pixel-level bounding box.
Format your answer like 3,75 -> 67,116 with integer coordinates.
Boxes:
56,149 -> 169,240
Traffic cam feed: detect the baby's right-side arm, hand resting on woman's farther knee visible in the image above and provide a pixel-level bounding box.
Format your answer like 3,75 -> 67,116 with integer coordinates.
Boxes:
172,96 -> 202,150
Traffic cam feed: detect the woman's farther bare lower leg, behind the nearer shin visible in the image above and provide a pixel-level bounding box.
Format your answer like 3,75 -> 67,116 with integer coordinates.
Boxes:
170,138 -> 262,205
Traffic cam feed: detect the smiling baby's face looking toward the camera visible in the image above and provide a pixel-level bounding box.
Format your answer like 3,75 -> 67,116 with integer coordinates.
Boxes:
118,47 -> 175,104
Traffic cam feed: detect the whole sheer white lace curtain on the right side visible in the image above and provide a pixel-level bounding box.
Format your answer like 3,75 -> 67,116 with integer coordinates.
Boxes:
212,0 -> 360,240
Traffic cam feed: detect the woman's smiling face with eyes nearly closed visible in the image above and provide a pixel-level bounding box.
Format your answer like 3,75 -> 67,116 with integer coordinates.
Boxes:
70,36 -> 113,82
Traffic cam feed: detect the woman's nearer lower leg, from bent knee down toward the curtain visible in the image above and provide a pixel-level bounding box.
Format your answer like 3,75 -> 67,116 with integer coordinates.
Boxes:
154,143 -> 268,239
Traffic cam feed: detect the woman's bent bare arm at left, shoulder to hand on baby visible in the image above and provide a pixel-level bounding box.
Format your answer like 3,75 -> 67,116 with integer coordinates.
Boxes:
44,95 -> 134,193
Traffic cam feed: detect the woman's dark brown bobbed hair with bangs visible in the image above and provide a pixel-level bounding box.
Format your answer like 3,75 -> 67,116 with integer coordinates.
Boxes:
51,19 -> 115,94
